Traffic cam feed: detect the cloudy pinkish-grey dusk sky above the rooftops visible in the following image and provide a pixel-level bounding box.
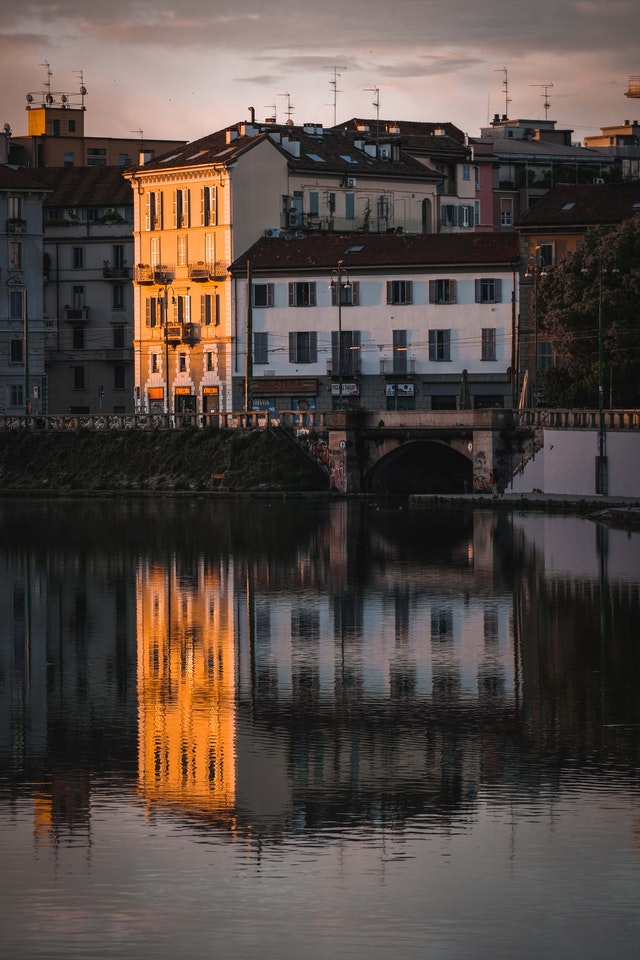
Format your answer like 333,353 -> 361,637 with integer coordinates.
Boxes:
0,0 -> 640,148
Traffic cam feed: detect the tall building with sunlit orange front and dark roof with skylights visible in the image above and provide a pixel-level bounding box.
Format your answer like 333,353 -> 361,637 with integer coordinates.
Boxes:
126,122 -> 441,413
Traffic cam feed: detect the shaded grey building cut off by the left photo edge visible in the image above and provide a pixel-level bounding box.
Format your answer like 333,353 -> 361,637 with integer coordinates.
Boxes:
0,165 -> 49,415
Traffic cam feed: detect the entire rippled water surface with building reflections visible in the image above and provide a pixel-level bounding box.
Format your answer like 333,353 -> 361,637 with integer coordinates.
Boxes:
0,500 -> 640,960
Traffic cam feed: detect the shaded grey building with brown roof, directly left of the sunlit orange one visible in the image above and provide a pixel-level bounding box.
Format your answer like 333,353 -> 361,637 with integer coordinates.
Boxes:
32,167 -> 133,413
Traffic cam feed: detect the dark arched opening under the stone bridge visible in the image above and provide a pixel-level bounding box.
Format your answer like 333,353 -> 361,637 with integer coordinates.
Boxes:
364,440 -> 473,496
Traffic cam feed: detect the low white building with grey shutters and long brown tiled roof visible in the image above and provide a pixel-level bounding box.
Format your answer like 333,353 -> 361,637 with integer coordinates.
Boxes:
231,234 -> 518,415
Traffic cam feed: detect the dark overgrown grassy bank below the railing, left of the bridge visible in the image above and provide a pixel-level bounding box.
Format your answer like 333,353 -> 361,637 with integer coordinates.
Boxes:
0,428 -> 328,493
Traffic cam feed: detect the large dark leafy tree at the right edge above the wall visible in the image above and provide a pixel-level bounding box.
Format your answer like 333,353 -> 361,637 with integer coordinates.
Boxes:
536,216 -> 640,409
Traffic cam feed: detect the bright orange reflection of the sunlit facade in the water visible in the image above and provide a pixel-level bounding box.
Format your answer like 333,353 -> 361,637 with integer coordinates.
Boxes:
136,559 -> 236,817
